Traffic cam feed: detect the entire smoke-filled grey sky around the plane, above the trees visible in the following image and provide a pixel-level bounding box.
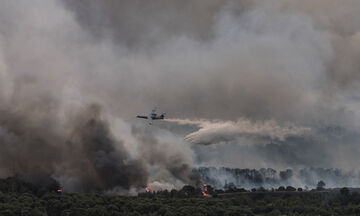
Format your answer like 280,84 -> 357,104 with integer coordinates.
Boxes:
0,0 -> 360,193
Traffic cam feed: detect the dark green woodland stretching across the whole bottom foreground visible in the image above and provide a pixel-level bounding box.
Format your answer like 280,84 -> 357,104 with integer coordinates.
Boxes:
0,177 -> 360,216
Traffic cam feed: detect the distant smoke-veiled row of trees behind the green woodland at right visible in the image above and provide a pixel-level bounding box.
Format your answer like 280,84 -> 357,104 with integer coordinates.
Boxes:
193,167 -> 360,188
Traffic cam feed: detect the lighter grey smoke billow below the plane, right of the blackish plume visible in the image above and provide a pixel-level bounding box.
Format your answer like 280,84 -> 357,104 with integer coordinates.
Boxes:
132,127 -> 199,188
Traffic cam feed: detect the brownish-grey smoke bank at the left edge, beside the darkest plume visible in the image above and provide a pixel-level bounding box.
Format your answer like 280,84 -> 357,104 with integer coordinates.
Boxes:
0,103 -> 64,177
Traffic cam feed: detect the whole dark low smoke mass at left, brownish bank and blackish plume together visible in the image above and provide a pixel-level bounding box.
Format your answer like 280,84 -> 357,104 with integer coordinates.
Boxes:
0,101 -> 147,191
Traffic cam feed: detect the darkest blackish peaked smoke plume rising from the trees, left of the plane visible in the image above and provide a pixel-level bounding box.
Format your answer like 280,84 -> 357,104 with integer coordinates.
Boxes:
64,105 -> 147,191
